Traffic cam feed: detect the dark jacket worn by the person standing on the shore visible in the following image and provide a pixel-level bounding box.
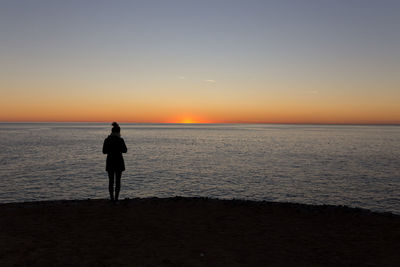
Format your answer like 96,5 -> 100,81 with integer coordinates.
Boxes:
103,135 -> 128,171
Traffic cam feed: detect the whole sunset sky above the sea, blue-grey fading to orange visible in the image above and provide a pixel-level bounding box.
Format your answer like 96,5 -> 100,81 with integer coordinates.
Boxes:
0,0 -> 400,124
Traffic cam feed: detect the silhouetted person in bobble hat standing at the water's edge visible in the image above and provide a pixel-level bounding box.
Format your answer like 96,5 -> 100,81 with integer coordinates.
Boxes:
103,122 -> 128,201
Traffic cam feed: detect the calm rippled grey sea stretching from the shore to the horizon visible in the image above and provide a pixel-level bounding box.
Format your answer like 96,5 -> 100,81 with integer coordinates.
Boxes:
0,123 -> 400,214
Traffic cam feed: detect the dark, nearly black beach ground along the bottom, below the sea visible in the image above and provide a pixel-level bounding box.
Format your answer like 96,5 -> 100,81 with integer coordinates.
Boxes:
0,197 -> 400,266
